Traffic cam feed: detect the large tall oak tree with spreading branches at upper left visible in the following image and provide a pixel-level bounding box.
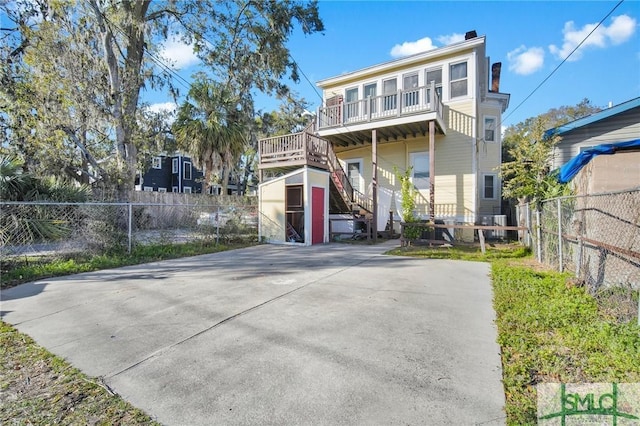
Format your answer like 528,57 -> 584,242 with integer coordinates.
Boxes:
0,0 -> 323,198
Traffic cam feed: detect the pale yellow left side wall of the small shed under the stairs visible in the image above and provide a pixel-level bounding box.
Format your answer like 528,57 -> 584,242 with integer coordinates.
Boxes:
259,179 -> 286,242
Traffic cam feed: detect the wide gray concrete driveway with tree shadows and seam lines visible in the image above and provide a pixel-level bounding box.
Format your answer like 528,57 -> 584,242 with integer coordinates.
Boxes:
1,243 -> 505,425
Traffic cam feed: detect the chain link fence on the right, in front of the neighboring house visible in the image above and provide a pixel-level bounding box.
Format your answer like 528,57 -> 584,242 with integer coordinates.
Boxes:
524,189 -> 640,321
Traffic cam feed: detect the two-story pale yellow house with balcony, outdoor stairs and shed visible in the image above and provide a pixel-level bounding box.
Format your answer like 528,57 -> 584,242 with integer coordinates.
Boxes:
259,31 -> 509,244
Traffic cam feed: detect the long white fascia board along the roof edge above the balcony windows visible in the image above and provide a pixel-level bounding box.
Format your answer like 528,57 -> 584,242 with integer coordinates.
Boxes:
316,36 -> 485,88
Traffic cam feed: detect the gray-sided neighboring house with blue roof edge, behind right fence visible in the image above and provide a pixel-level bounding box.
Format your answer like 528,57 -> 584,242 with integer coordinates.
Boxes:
546,97 -> 640,194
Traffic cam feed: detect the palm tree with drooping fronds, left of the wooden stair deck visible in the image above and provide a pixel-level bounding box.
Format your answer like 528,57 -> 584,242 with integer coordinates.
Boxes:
173,78 -> 246,193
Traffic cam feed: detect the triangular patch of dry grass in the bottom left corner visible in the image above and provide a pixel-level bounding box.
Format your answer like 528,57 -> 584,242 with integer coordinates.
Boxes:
0,321 -> 158,425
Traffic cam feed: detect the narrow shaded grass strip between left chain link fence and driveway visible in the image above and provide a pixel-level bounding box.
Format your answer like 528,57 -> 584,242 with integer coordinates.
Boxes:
0,241 -> 252,288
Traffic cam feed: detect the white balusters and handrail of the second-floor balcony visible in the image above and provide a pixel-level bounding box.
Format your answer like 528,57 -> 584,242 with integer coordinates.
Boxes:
317,82 -> 442,129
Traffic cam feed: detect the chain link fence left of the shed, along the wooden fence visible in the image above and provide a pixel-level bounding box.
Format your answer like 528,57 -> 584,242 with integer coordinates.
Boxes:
0,198 -> 258,260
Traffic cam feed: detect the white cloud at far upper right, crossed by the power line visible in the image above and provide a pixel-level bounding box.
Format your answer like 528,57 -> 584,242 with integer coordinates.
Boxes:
549,15 -> 636,61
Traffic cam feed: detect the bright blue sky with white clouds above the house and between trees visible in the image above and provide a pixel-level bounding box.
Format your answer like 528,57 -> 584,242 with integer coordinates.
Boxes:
151,0 -> 640,127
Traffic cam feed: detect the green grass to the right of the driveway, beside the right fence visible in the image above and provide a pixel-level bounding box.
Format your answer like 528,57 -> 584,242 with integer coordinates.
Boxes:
387,246 -> 640,425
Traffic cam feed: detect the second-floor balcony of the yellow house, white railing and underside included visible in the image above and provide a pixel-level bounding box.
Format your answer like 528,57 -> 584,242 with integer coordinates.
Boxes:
316,84 -> 446,145
